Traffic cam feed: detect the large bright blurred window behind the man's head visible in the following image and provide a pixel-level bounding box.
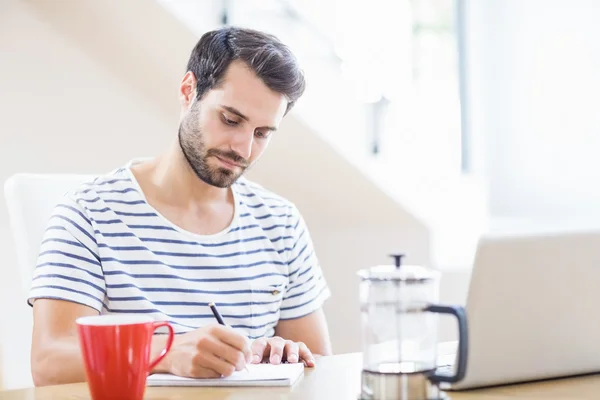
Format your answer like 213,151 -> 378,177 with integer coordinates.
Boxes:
216,0 -> 469,174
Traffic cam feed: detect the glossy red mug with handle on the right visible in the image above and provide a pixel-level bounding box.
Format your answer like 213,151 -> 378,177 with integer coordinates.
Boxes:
76,314 -> 174,400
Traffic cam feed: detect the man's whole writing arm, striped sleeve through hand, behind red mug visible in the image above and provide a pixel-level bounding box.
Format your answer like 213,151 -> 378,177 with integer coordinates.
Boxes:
29,199 -> 251,386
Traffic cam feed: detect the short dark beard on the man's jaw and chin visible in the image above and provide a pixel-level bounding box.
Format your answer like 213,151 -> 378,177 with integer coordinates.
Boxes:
178,107 -> 249,188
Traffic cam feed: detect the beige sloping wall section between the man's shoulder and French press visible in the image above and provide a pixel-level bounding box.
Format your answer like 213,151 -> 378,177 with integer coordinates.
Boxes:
248,118 -> 430,353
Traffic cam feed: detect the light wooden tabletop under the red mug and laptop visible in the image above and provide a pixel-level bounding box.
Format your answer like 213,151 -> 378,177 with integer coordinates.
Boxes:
0,353 -> 600,400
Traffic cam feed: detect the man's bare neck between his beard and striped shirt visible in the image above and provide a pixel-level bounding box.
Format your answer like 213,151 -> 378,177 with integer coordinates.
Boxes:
142,140 -> 233,205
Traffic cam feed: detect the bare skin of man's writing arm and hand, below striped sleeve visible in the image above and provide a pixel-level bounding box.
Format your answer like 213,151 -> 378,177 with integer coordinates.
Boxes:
31,299 -> 251,386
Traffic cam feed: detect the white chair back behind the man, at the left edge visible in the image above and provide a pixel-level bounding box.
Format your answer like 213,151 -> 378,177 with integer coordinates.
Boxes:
0,173 -> 92,390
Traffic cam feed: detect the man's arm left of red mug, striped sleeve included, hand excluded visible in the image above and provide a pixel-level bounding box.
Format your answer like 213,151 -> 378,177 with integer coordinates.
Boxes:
28,198 -> 105,386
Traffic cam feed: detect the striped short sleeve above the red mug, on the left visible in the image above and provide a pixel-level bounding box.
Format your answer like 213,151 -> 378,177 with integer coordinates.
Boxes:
27,198 -> 106,312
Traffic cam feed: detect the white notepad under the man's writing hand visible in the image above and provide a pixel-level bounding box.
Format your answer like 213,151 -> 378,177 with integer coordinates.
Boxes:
146,363 -> 304,386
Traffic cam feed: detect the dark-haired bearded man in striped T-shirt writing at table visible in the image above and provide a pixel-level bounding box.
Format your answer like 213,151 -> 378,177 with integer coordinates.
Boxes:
29,28 -> 331,386
